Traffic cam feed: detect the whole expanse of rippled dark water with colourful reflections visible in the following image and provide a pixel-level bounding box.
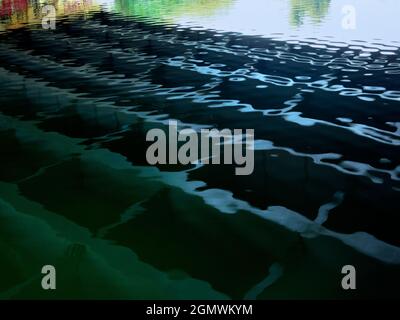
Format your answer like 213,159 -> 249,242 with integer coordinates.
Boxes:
0,0 -> 400,299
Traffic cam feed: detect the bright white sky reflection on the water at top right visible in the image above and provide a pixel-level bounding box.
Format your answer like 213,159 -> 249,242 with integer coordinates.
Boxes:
174,0 -> 400,47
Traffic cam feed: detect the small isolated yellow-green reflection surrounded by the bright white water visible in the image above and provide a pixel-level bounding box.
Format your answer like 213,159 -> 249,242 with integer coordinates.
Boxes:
290,0 -> 331,27
